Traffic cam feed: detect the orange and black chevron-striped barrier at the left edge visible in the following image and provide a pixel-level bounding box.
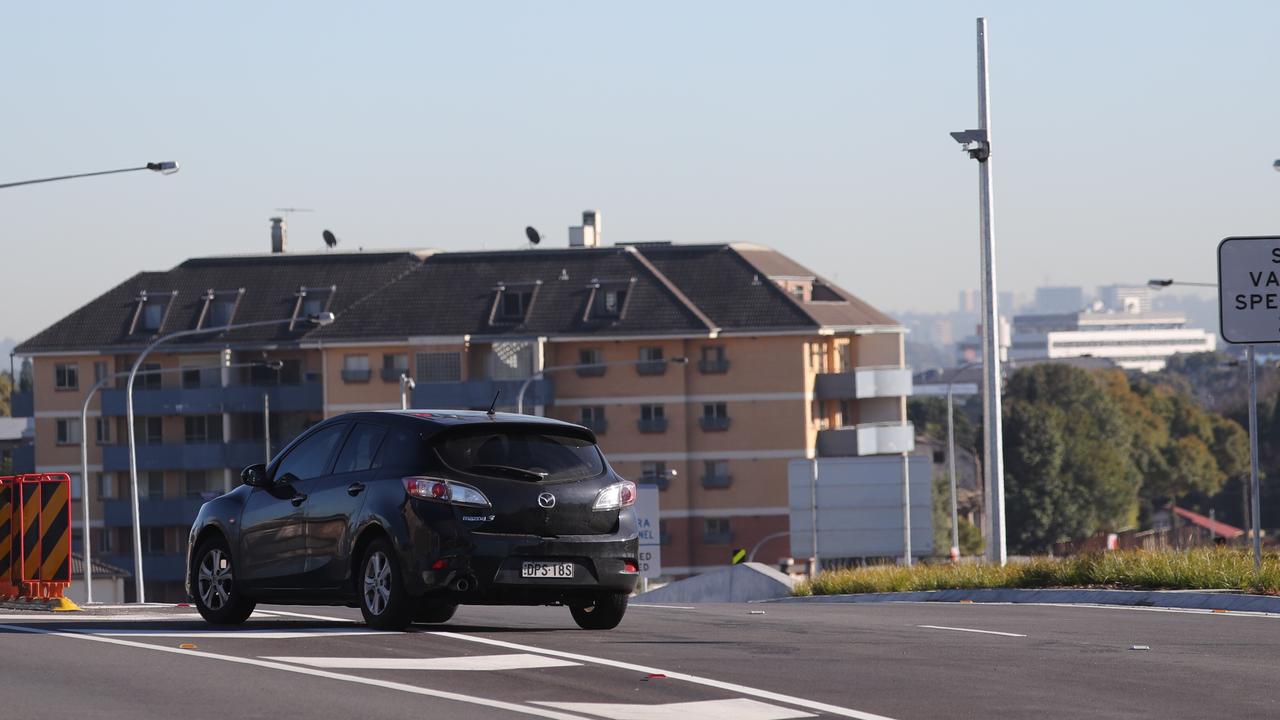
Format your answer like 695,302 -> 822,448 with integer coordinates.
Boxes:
0,473 -> 74,607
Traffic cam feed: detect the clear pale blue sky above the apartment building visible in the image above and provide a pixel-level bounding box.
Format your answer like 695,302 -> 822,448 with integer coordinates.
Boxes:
0,1 -> 1280,338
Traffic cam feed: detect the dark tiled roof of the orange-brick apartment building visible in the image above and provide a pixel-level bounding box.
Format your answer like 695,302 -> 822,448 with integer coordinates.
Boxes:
17,243 -> 897,354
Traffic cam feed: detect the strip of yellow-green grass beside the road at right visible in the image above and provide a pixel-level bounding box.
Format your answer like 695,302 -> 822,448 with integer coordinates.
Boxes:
794,548 -> 1280,596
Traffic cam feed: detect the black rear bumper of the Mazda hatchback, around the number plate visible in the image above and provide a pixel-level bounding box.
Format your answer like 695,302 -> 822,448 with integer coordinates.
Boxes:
404,504 -> 639,605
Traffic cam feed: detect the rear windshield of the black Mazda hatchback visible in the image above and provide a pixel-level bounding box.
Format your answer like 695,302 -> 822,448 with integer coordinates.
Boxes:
435,427 -> 604,482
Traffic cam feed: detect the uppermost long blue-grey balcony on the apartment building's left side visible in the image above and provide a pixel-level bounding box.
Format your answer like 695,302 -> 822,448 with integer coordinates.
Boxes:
102,383 -> 324,418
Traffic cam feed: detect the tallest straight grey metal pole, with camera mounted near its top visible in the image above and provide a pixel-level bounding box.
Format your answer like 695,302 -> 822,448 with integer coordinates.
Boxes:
978,18 -> 1009,565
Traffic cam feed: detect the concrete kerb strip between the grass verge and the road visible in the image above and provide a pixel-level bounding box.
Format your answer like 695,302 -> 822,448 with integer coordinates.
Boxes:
762,588 -> 1280,614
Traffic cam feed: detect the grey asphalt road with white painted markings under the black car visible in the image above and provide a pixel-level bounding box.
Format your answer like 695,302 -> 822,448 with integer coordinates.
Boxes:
0,603 -> 1280,720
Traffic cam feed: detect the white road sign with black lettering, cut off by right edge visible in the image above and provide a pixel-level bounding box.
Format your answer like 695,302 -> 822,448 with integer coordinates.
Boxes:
1217,237 -> 1280,345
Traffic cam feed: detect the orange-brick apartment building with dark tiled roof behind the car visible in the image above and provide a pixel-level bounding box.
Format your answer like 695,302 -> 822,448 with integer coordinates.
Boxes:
15,237 -> 911,600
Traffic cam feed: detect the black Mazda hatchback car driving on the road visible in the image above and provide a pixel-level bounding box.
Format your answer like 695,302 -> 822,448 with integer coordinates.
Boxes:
187,410 -> 639,629
